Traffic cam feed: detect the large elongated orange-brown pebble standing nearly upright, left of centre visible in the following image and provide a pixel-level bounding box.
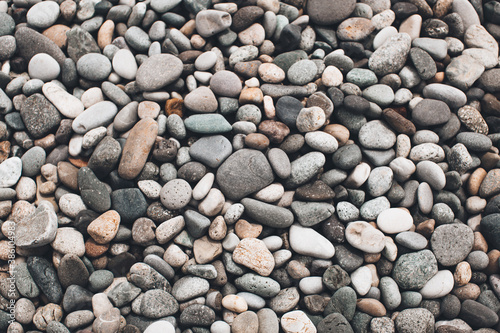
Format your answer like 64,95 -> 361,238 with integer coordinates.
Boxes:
118,118 -> 158,179
